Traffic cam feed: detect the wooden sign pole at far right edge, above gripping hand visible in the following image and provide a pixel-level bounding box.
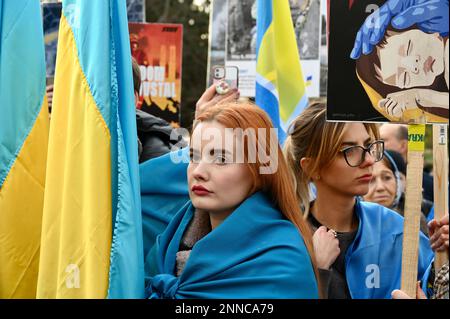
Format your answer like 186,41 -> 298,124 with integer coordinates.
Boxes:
433,124 -> 448,273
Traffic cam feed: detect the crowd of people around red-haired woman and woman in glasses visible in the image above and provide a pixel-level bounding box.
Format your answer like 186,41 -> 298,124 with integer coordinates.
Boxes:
124,53 -> 448,299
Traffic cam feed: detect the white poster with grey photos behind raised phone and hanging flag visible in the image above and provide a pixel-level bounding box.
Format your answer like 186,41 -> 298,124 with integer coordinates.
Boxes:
208,0 -> 326,97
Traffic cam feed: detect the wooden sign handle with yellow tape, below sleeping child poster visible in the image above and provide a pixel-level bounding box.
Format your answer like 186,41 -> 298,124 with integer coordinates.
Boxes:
401,124 -> 425,298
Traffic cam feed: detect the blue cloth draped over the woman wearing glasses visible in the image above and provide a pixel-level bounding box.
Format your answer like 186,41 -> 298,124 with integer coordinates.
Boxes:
345,200 -> 434,299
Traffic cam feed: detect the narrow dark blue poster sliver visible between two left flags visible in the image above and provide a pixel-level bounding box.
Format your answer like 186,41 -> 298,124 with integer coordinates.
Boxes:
42,3 -> 62,82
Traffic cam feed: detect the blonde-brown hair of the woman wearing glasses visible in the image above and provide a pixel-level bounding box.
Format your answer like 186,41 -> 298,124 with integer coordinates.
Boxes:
283,103 -> 379,218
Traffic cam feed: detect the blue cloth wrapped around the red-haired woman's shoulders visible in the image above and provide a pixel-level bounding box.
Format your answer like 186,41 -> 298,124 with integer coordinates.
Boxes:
147,192 -> 318,299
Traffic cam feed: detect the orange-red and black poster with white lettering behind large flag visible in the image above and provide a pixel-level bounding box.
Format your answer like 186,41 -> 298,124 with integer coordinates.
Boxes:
129,23 -> 183,127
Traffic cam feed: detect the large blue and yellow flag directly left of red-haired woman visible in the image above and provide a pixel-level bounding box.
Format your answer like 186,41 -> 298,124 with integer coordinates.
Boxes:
37,0 -> 144,298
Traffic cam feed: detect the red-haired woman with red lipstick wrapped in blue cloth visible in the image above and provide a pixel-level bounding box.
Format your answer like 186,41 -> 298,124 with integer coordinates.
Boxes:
144,102 -> 318,298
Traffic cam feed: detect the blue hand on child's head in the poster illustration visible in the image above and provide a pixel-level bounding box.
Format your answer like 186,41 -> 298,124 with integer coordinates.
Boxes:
350,0 -> 449,60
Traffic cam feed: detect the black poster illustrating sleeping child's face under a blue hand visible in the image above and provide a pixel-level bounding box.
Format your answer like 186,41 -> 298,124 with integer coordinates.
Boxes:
327,0 -> 449,123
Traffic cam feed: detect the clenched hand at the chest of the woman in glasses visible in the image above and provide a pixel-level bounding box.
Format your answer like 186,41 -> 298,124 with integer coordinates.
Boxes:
313,226 -> 341,270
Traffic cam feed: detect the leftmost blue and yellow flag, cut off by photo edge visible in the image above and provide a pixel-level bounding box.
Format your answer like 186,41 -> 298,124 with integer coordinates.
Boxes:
0,0 -> 49,299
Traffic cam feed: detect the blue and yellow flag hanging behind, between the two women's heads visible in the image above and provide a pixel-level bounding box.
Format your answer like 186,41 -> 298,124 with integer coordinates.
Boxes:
256,0 -> 308,143
